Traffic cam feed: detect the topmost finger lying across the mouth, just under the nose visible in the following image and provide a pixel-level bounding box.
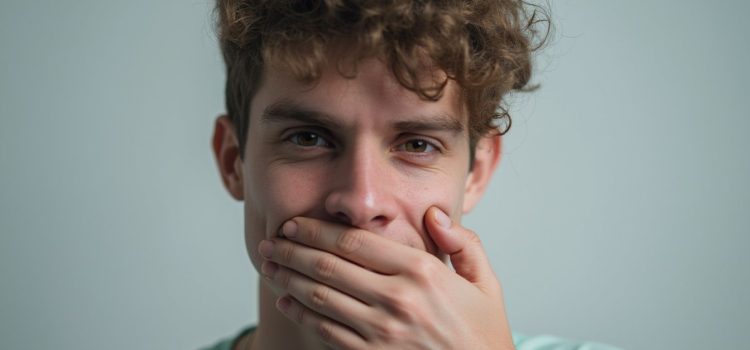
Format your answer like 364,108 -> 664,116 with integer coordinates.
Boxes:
282,217 -> 422,275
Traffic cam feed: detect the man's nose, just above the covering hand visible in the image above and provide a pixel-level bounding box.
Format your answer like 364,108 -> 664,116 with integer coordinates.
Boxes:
325,141 -> 397,231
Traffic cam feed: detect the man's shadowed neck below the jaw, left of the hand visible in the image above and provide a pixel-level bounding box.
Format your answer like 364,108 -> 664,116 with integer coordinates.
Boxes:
249,279 -> 329,350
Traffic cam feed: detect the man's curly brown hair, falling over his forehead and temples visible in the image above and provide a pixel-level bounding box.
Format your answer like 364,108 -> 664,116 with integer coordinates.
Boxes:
216,0 -> 549,155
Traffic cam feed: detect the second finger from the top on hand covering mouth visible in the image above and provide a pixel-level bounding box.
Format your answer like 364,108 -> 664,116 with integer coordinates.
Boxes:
261,239 -> 384,304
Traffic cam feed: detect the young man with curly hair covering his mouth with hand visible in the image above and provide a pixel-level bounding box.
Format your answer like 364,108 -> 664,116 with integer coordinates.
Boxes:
207,0 -> 624,349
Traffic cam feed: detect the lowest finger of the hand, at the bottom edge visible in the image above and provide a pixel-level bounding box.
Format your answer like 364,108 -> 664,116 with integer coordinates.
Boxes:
276,296 -> 366,349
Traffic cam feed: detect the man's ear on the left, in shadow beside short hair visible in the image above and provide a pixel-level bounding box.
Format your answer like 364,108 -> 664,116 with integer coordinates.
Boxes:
211,115 -> 245,200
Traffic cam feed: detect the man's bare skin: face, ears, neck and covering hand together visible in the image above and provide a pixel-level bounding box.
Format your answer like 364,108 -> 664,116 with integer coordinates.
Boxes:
213,59 -> 513,349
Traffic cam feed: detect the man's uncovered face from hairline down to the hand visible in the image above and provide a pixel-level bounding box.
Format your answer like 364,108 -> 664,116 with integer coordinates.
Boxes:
241,59 -> 476,269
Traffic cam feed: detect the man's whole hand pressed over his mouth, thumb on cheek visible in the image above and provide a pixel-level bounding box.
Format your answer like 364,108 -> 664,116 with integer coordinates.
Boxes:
259,208 -> 513,349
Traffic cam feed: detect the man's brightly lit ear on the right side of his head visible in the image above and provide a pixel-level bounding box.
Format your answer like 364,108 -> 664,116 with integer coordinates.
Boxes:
463,133 -> 503,214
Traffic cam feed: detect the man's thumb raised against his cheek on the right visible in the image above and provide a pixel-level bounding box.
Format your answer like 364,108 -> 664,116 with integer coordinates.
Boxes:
424,207 -> 495,285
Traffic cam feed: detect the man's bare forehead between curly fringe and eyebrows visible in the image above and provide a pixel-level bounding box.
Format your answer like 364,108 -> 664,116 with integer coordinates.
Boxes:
250,59 -> 468,130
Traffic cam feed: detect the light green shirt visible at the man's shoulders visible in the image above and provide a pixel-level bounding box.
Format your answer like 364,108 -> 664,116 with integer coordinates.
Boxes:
203,327 -> 621,350
